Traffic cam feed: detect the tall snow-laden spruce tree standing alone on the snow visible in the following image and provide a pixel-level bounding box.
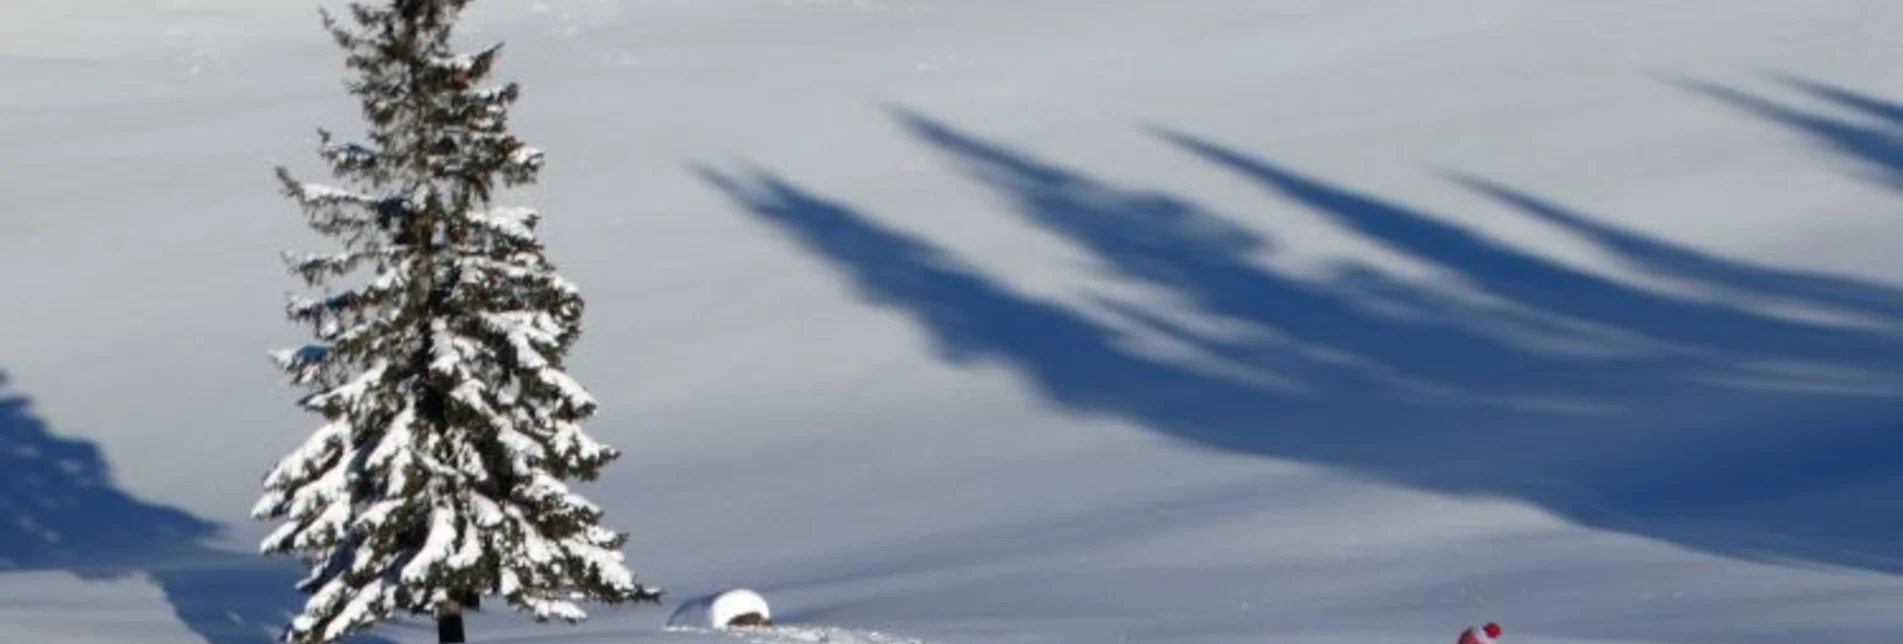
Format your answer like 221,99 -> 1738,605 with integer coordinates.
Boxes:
253,0 -> 660,642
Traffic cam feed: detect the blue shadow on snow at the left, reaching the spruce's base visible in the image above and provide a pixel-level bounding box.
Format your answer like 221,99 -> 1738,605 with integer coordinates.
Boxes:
0,372 -> 388,644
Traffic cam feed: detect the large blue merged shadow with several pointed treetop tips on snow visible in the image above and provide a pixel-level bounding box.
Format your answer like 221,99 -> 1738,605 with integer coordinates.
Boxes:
698,104 -> 1903,572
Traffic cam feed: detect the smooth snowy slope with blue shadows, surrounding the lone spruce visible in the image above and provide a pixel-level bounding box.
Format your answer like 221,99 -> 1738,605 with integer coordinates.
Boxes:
0,0 -> 1903,644
